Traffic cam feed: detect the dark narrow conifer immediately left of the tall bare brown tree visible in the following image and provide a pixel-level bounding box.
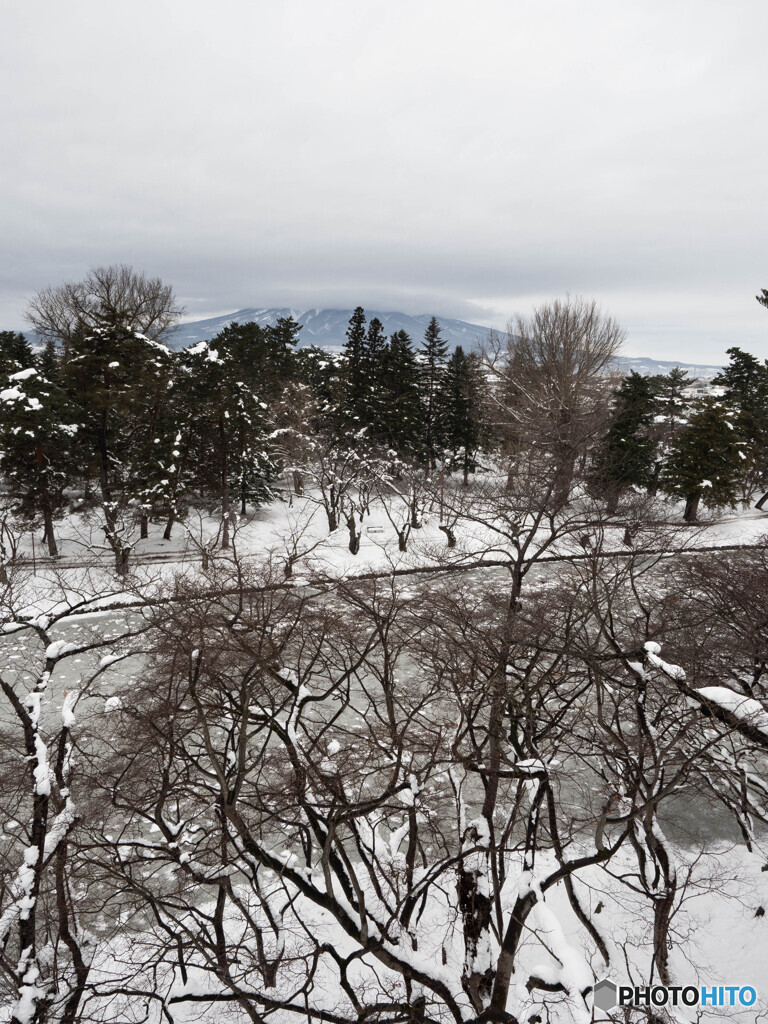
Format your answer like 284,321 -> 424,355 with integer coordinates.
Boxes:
440,345 -> 482,485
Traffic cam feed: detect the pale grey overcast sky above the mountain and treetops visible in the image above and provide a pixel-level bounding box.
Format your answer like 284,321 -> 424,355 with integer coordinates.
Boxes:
0,0 -> 768,362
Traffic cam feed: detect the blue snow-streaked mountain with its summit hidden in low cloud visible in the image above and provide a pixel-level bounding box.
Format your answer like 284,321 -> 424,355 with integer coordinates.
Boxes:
168,307 -> 488,349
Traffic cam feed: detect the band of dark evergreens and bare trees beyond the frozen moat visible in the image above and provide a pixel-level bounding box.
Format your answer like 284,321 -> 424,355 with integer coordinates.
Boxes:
0,266 -> 768,565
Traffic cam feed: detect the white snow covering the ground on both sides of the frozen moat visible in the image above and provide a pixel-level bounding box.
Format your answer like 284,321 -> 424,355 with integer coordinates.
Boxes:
0,483 -> 768,1024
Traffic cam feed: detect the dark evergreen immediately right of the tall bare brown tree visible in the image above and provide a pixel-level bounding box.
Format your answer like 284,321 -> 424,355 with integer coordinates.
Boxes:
594,370 -> 657,510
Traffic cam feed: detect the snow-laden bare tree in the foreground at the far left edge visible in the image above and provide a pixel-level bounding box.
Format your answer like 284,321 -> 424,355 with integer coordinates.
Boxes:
0,567 -> 154,1024
